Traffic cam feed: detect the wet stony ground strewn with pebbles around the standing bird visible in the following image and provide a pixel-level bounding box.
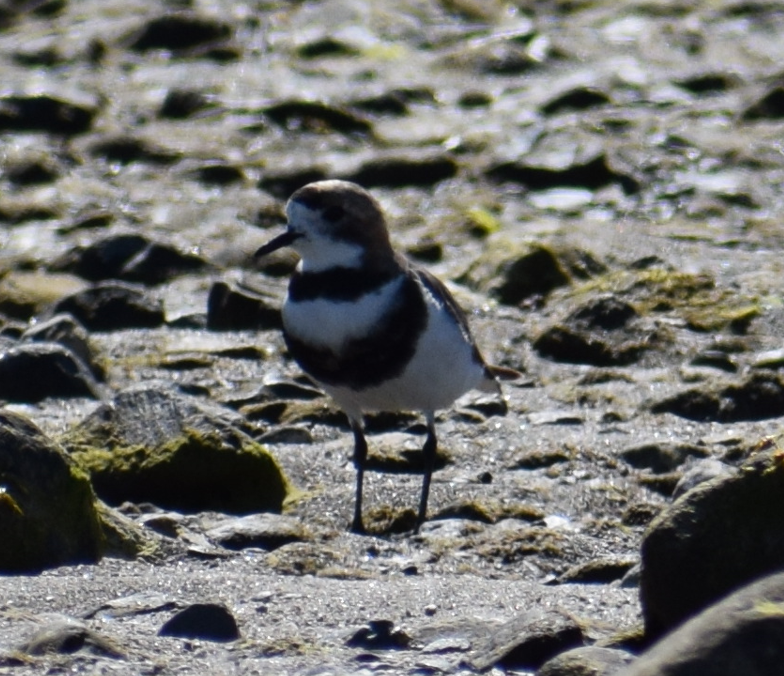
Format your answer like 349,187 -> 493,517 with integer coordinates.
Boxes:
0,0 -> 784,674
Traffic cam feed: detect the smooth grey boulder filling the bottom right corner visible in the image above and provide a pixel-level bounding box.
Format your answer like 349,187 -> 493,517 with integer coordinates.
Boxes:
616,573 -> 784,676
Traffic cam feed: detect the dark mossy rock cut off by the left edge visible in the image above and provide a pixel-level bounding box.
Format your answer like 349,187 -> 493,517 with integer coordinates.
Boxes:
0,410 -> 103,573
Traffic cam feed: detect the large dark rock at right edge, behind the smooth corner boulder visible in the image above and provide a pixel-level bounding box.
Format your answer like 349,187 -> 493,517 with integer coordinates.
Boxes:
640,452 -> 784,637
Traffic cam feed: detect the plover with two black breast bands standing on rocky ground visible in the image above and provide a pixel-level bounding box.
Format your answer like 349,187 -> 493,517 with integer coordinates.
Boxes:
256,180 -> 520,533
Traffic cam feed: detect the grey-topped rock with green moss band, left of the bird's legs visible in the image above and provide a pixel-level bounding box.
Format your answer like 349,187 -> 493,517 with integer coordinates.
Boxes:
63,384 -> 289,514
